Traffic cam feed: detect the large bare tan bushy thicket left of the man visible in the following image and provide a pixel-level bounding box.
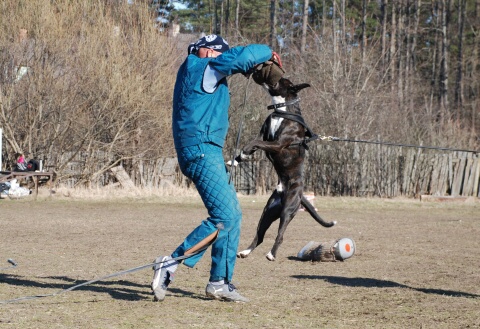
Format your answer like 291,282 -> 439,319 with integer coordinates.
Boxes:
0,1 -> 177,184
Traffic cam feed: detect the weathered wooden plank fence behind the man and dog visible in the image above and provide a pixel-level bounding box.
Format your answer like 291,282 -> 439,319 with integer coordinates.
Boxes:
61,143 -> 480,197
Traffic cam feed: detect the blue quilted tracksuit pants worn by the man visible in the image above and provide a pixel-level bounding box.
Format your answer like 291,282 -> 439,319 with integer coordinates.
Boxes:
172,143 -> 242,282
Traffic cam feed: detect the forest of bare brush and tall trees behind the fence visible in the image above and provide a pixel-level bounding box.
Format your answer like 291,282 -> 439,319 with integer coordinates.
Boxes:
0,0 -> 480,195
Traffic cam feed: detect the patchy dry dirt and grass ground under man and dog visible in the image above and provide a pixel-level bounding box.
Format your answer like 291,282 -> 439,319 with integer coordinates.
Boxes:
0,191 -> 480,329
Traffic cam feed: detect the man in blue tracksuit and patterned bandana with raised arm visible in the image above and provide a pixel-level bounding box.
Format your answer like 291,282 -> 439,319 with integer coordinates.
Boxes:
152,35 -> 277,302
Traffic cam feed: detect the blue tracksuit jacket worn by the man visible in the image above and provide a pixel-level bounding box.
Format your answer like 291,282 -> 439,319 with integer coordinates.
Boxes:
172,45 -> 272,149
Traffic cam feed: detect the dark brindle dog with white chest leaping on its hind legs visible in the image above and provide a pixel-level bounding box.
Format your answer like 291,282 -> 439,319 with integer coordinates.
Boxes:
237,78 -> 336,261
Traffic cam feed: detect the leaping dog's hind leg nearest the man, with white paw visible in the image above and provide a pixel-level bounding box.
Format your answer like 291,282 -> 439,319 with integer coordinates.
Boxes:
237,190 -> 282,258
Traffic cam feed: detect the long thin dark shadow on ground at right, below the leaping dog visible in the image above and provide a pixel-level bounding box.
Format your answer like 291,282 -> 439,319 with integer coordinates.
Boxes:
292,275 -> 480,298
